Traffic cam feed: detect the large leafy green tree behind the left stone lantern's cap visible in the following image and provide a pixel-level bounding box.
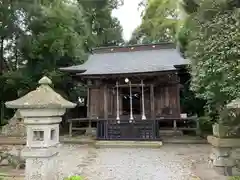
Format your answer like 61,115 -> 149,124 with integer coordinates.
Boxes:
0,0 -> 89,122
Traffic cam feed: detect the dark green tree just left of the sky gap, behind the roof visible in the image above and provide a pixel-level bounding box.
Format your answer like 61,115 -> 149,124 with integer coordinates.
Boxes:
78,0 -> 124,48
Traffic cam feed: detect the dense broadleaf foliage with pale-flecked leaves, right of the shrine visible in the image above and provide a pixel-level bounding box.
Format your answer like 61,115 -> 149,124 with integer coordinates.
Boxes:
188,11 -> 240,111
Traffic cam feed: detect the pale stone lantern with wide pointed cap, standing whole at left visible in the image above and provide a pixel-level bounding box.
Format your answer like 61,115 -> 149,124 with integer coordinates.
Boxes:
6,77 -> 76,180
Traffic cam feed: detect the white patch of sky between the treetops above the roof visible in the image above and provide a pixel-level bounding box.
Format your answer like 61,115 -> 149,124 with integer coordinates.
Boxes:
112,0 -> 141,40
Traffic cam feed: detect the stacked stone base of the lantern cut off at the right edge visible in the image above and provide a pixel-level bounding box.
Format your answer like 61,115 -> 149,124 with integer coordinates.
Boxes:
208,136 -> 240,176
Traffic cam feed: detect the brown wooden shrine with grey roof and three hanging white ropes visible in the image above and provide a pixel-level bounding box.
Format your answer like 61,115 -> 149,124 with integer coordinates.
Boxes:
61,43 -> 198,140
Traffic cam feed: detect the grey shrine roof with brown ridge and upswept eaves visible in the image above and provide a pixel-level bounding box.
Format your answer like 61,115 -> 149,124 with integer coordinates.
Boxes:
61,43 -> 188,75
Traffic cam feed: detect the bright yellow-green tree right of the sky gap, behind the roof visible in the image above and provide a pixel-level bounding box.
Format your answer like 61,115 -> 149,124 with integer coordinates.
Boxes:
129,0 -> 179,44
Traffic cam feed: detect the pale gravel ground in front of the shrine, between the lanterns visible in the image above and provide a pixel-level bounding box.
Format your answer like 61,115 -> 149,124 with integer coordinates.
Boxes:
54,144 -> 227,180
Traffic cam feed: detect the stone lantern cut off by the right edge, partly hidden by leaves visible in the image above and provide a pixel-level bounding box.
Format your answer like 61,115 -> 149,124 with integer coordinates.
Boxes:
208,98 -> 240,176
